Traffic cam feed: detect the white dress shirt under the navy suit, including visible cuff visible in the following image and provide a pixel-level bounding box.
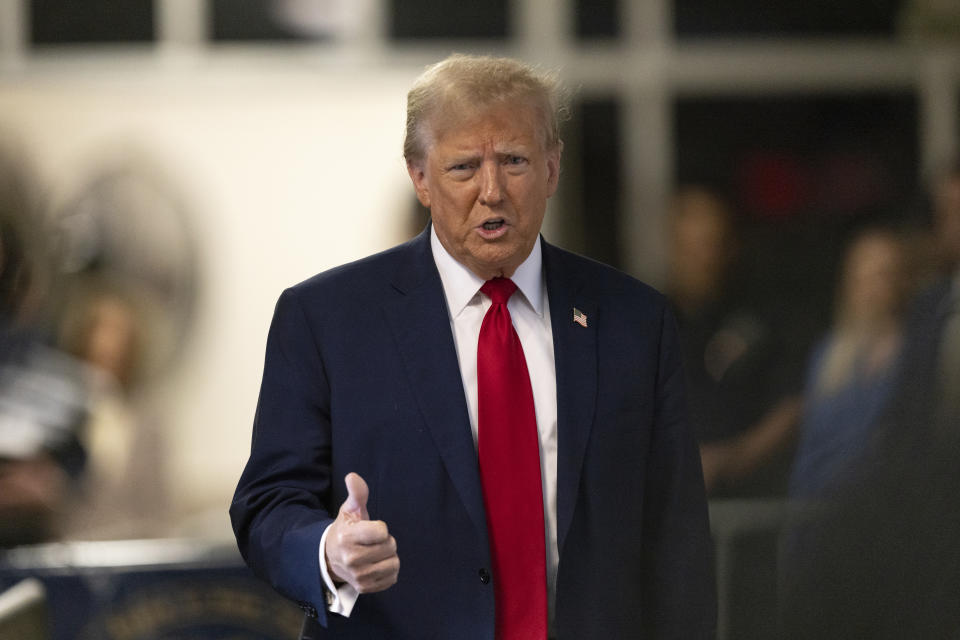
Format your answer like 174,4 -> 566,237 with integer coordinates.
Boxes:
320,228 -> 559,626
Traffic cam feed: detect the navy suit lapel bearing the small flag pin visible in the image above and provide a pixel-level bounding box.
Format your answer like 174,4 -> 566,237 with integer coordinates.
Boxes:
543,242 -> 599,557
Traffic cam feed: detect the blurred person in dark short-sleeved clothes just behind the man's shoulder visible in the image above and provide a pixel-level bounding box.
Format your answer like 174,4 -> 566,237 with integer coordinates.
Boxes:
668,186 -> 801,496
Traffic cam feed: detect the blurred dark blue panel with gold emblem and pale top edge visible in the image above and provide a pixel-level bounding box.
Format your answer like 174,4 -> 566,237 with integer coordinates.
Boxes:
0,540 -> 303,640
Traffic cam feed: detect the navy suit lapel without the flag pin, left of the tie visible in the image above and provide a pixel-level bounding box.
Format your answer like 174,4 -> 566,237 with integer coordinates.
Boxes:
384,227 -> 487,541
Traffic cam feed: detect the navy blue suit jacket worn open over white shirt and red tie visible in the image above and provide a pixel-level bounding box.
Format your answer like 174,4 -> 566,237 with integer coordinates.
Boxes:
231,228 -> 716,640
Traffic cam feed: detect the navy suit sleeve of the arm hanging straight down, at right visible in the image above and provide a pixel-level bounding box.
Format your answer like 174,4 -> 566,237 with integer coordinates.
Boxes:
642,307 -> 717,640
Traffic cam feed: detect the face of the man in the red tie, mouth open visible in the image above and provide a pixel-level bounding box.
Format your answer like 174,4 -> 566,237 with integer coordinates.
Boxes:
407,102 -> 560,280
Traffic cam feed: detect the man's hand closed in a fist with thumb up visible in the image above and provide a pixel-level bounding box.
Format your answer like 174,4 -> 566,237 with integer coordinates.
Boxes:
326,473 -> 400,593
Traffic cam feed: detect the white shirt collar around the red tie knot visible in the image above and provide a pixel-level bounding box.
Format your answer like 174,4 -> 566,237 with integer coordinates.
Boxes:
430,225 -> 543,318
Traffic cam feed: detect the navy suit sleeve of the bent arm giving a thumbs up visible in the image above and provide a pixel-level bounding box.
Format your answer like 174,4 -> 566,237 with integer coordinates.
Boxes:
230,289 -> 333,624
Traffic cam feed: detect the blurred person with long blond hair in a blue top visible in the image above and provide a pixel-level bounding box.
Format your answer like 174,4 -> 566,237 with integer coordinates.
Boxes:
789,229 -> 909,499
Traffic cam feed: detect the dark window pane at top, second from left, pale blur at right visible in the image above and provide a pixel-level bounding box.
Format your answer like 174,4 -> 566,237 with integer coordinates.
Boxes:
209,0 -> 333,41
